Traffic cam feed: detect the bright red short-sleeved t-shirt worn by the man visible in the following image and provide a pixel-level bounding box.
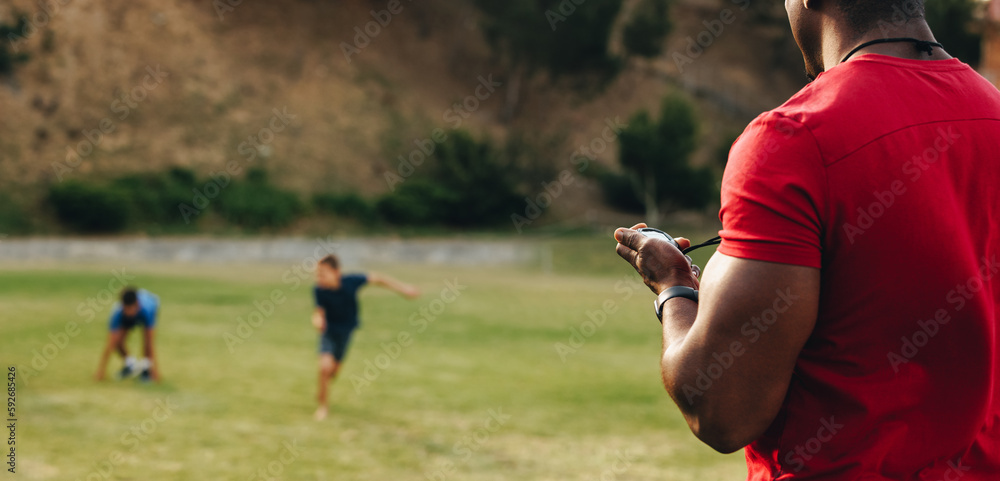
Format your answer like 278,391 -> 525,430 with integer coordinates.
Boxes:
719,55 -> 1000,481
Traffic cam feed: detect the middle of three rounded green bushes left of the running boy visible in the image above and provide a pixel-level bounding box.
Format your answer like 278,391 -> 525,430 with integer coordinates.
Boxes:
112,167 -> 197,225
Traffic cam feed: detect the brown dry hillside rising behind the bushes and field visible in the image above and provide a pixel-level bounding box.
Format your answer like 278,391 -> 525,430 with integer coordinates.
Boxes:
0,0 -> 800,225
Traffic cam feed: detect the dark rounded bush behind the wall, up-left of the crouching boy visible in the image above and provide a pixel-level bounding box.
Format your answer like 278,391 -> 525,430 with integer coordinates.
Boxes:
48,180 -> 129,233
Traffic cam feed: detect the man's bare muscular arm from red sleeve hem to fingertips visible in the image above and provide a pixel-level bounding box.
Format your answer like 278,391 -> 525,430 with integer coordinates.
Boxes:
615,224 -> 820,452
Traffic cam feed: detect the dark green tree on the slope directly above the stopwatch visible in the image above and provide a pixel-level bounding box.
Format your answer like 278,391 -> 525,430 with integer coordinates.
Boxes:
619,94 -> 714,224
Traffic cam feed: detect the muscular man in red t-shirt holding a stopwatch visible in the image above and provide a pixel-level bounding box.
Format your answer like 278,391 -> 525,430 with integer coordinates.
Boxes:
615,0 -> 1000,481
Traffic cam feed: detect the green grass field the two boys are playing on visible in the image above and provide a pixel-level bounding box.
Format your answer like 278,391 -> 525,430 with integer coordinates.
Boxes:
0,240 -> 746,480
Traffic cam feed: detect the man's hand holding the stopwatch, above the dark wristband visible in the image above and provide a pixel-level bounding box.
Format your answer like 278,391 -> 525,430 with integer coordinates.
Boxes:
615,224 -> 698,294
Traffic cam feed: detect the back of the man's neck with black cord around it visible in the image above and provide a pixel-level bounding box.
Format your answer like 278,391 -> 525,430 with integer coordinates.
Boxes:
823,18 -> 951,70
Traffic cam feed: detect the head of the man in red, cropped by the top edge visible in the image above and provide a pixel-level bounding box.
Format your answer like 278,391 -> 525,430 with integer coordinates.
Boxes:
785,0 -> 924,77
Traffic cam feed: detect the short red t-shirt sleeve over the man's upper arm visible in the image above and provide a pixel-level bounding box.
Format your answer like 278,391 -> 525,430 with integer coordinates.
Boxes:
719,112 -> 827,268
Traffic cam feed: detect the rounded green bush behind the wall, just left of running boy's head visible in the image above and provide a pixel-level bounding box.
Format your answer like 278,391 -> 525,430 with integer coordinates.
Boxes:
220,169 -> 305,230
